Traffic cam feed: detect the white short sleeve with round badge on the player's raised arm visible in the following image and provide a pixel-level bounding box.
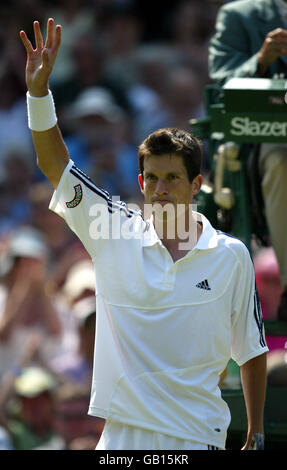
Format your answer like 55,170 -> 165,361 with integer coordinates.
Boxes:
49,160 -> 138,258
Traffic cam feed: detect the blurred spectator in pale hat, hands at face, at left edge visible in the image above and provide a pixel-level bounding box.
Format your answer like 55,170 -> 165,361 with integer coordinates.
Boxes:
0,227 -> 61,378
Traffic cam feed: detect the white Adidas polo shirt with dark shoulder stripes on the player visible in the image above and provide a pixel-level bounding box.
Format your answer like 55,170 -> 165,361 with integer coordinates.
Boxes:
50,161 -> 268,448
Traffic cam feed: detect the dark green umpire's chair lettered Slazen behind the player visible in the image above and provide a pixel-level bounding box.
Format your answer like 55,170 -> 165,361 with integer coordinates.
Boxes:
190,78 -> 287,449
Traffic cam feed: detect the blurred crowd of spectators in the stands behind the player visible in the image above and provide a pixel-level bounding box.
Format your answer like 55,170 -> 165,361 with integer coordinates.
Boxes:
0,0 -> 282,449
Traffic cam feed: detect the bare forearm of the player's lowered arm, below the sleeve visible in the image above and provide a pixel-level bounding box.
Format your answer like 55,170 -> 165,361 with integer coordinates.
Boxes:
240,353 -> 266,437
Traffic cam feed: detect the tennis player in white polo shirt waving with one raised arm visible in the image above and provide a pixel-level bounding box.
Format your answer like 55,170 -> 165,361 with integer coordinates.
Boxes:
20,19 -> 268,450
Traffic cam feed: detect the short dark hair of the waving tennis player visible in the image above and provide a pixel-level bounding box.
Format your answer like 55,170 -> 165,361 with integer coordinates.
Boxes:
138,127 -> 202,182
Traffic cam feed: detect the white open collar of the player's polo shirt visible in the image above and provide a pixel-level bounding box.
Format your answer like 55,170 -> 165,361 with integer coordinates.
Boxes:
142,211 -> 217,250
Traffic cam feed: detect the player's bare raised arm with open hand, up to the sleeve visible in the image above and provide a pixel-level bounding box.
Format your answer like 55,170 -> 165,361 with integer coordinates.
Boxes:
20,18 -> 69,188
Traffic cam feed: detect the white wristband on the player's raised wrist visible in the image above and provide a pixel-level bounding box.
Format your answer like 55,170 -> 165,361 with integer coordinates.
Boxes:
27,90 -> 57,132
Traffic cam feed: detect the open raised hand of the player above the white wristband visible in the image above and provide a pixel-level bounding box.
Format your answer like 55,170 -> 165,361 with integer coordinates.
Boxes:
20,18 -> 62,96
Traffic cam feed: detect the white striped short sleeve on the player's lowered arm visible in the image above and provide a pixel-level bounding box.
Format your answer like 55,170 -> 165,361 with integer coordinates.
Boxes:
231,244 -> 268,366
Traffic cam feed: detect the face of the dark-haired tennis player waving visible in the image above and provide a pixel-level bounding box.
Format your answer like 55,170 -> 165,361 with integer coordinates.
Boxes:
139,155 -> 202,209
